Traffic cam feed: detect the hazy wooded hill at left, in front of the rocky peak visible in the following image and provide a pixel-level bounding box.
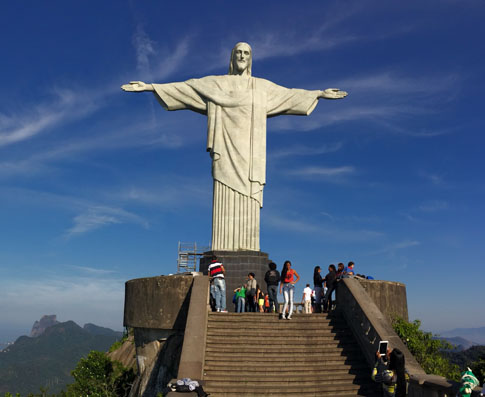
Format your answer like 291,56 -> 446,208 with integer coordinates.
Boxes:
0,321 -> 122,395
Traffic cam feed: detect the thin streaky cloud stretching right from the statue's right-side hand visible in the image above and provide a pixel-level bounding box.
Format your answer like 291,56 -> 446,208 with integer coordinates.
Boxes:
268,72 -> 461,133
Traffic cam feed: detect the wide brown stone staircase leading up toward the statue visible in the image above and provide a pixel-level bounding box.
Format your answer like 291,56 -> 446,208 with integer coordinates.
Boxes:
204,313 -> 379,397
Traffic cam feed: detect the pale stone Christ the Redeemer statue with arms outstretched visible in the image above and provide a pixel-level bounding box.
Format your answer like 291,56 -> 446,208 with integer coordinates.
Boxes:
121,43 -> 347,251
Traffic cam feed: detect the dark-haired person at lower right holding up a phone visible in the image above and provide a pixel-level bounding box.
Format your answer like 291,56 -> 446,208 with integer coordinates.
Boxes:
372,349 -> 406,397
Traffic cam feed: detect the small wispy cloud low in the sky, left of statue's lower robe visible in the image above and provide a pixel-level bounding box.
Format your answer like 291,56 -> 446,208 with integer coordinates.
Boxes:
66,206 -> 149,238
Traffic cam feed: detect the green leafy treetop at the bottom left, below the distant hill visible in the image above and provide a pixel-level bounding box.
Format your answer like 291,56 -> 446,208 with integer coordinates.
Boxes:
66,350 -> 135,397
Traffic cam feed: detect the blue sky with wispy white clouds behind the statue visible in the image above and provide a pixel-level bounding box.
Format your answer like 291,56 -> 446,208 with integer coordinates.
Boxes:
0,0 -> 485,341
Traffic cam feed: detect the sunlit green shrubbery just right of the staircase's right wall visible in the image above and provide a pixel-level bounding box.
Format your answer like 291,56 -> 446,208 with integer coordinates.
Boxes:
392,318 -> 460,380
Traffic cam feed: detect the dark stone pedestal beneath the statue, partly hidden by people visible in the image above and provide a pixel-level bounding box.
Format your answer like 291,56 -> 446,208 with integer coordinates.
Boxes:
199,251 -> 271,312
